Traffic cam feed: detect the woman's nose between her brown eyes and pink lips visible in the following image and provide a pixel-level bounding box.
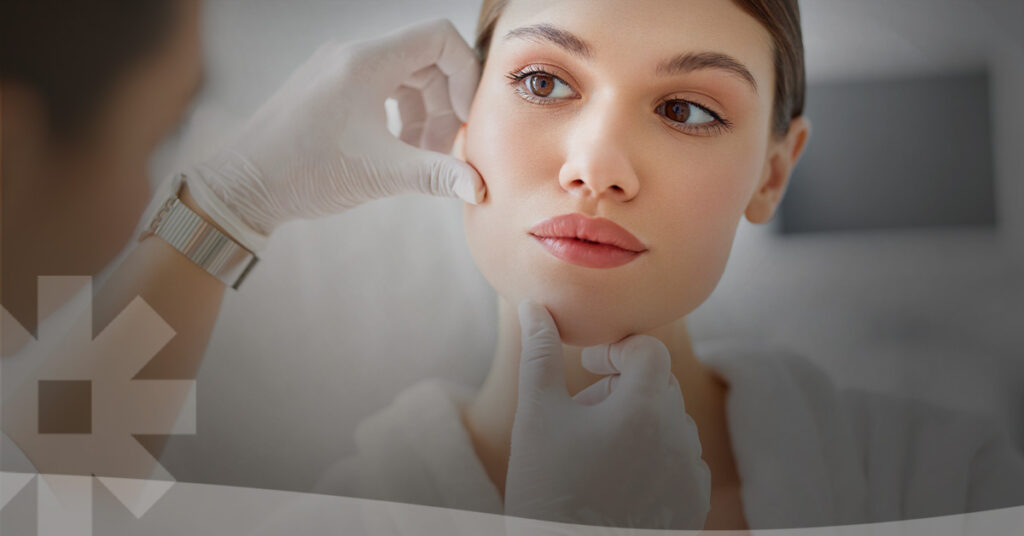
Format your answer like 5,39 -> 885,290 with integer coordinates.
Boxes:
558,102 -> 640,202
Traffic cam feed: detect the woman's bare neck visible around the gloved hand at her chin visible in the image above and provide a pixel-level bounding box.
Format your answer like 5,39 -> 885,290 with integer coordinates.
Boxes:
463,297 -> 734,493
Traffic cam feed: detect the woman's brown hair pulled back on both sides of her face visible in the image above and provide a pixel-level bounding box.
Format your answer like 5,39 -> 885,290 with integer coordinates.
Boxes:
474,0 -> 807,136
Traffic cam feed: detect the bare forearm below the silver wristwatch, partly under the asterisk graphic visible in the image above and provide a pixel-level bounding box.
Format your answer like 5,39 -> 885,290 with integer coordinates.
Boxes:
3,183 -> 237,478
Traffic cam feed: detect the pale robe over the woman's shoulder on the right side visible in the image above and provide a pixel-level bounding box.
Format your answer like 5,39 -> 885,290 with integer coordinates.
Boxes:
698,342 -> 1024,522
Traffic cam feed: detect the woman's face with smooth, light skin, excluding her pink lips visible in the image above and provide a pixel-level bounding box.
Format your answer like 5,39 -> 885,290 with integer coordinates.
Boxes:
460,0 -> 799,346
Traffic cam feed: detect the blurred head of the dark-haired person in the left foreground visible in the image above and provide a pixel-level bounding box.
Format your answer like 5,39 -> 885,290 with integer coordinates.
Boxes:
0,0 -> 202,332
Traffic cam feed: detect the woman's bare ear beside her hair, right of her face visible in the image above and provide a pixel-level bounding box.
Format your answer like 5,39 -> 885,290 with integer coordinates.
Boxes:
745,116 -> 811,223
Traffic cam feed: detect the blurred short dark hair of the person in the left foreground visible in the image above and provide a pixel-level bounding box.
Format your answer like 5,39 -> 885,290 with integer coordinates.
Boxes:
0,0 -> 181,139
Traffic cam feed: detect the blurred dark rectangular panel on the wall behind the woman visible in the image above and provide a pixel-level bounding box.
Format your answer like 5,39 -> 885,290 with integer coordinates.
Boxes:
778,74 -> 996,234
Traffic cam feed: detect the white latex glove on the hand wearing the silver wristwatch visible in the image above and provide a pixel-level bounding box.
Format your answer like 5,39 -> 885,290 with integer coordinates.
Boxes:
186,18 -> 485,250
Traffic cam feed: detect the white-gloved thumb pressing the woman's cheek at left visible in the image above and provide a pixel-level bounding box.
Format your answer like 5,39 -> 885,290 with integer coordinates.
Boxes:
395,143 -> 486,205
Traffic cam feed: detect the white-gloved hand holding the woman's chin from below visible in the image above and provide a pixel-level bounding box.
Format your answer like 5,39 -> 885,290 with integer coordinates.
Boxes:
505,301 -> 711,530
